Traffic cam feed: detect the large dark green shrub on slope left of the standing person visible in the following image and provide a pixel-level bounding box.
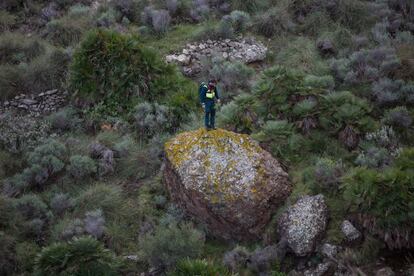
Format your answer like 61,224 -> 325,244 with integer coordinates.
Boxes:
69,29 -> 196,117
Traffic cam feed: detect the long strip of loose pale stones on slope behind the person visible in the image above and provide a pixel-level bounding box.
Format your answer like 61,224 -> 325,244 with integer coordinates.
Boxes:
166,38 -> 267,76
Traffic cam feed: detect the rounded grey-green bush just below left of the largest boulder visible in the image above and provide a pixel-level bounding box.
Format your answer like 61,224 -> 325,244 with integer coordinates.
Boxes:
140,224 -> 204,268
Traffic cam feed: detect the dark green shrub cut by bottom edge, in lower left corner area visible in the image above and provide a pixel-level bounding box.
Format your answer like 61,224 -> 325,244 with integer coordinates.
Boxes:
35,237 -> 120,276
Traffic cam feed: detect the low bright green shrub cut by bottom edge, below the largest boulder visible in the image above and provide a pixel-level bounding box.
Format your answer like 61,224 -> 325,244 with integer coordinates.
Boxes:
168,259 -> 231,276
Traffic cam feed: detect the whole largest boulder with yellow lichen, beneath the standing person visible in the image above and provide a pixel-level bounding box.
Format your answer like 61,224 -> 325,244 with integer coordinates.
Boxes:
164,129 -> 291,240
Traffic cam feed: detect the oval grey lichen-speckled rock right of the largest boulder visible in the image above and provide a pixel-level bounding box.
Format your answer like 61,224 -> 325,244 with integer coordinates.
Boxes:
278,195 -> 328,256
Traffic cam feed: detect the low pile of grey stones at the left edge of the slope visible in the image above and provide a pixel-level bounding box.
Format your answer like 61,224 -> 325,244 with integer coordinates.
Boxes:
0,89 -> 68,117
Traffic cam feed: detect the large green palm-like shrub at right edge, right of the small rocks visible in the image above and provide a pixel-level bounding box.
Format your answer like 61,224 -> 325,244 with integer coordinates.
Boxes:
343,148 -> 414,248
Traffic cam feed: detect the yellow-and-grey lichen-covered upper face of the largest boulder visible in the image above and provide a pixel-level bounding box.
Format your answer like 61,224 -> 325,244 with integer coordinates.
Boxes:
165,129 -> 272,203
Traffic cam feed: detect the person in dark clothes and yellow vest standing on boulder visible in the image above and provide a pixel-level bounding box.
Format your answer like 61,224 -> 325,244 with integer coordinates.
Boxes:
199,80 -> 220,130
